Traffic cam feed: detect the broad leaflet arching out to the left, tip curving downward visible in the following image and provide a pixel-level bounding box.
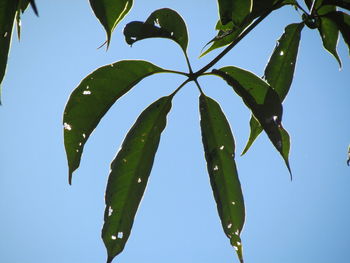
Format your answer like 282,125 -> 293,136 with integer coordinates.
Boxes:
63,60 -> 167,183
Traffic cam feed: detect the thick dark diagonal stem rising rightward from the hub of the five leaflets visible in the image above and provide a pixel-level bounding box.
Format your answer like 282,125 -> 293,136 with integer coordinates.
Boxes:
193,1 -> 281,79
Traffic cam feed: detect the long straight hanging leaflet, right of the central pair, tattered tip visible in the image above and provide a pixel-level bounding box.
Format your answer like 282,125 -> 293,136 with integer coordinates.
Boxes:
199,94 -> 245,262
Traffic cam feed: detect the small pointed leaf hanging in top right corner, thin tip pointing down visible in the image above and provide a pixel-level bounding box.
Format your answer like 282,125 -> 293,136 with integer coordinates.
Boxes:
317,6 -> 342,68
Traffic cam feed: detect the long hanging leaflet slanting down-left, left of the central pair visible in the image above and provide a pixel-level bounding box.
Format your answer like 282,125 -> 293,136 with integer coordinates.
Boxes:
102,95 -> 173,263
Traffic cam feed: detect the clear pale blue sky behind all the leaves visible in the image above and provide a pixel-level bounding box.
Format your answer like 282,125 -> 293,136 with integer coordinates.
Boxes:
0,0 -> 350,263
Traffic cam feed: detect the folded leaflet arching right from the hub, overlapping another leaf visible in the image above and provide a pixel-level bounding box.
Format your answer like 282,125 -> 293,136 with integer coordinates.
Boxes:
212,66 -> 291,174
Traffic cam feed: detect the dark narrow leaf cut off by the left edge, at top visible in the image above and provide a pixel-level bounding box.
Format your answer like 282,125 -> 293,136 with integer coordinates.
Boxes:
0,0 -> 18,99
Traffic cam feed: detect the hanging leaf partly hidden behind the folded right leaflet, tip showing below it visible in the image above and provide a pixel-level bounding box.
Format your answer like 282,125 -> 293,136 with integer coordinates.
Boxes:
242,23 -> 304,155
